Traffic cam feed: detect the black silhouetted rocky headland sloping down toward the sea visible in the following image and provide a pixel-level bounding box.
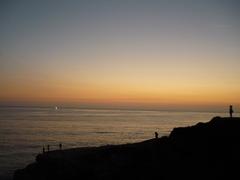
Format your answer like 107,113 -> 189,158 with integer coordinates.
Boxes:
14,117 -> 240,180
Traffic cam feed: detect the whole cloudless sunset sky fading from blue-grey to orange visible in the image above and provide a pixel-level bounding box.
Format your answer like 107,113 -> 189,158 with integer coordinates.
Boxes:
0,0 -> 240,108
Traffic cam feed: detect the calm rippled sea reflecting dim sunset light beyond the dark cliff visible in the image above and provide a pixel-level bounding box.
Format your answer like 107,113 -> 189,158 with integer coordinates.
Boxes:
0,107 -> 237,179
